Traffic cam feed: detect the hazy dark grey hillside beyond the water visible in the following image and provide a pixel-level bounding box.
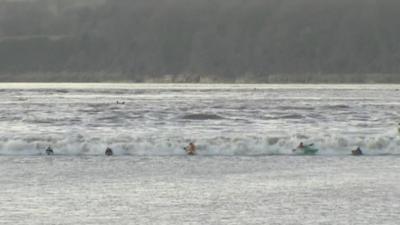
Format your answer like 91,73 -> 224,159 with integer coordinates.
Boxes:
0,0 -> 400,82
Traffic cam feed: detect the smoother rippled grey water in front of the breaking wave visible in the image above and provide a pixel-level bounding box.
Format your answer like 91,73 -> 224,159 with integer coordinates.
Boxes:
0,156 -> 400,225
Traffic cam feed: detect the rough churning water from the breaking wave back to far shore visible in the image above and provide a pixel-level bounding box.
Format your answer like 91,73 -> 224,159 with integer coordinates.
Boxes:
0,84 -> 400,156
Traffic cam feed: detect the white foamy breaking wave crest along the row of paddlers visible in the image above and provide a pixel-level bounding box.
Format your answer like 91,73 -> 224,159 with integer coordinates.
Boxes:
0,133 -> 400,156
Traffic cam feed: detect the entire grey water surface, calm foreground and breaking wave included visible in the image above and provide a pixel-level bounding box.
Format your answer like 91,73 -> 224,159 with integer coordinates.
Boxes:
0,84 -> 400,225
